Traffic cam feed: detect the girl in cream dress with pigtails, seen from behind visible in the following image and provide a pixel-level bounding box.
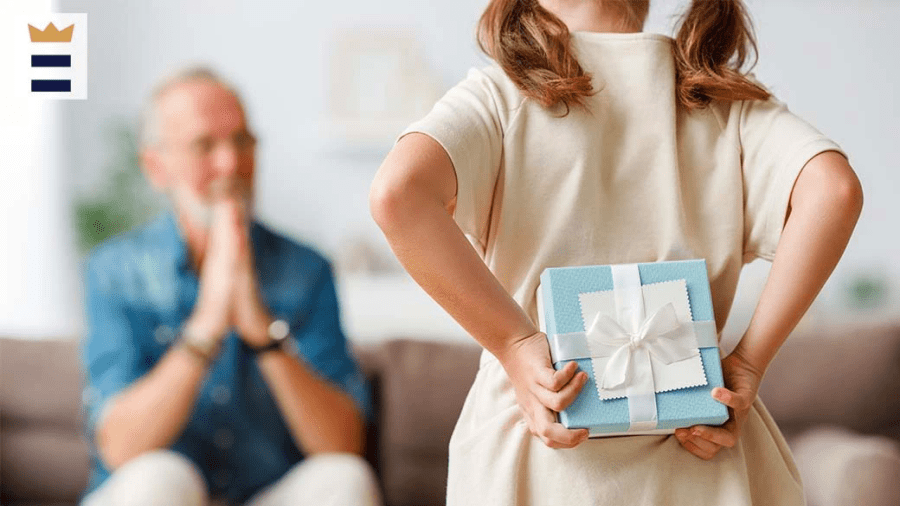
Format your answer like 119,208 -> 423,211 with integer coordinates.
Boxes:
370,0 -> 862,506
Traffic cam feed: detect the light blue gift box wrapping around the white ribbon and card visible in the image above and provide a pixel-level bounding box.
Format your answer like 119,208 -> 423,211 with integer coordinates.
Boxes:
538,260 -> 728,436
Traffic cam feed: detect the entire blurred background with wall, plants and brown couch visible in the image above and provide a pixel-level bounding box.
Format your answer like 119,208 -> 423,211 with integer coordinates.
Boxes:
0,0 -> 900,506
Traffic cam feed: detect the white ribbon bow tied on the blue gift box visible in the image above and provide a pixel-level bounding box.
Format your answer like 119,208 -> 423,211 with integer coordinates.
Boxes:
586,302 -> 699,390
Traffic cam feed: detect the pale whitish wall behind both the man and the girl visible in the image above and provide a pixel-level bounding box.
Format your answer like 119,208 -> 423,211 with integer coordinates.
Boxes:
15,0 -> 900,344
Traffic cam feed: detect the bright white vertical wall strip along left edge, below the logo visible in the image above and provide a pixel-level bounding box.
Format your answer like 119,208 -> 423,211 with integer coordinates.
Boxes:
0,0 -> 82,337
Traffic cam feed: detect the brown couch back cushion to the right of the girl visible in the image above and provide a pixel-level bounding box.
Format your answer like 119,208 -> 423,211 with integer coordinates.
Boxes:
759,323 -> 900,432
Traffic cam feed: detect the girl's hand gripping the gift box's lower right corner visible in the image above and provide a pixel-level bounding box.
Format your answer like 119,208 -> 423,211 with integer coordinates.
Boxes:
675,350 -> 763,460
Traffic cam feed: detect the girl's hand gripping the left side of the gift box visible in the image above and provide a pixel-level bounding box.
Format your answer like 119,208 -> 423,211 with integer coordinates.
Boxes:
497,332 -> 588,448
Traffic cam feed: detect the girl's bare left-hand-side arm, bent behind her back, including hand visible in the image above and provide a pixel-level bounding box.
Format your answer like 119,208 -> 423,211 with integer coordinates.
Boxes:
369,133 -> 587,447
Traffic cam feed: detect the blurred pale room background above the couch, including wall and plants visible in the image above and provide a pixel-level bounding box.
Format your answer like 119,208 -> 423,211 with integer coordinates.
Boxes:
0,0 -> 900,340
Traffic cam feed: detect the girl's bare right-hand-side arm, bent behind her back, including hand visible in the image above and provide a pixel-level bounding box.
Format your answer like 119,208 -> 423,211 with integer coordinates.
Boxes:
675,151 -> 863,458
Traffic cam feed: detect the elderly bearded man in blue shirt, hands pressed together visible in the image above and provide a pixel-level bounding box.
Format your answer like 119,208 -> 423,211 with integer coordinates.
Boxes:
83,69 -> 379,506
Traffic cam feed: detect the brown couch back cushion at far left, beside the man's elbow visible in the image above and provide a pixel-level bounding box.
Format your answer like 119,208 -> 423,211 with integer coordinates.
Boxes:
0,338 -> 82,430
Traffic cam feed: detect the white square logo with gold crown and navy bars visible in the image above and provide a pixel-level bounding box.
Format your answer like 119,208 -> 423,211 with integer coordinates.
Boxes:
16,13 -> 88,100
